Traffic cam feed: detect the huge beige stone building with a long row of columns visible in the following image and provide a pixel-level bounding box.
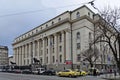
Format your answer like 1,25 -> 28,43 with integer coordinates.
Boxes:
13,6 -> 114,69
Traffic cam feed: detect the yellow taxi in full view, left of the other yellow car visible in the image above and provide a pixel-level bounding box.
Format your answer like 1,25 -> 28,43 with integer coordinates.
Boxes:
57,69 -> 79,77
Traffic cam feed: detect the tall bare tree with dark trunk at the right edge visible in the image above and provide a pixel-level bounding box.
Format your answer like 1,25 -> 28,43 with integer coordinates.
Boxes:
94,7 -> 120,73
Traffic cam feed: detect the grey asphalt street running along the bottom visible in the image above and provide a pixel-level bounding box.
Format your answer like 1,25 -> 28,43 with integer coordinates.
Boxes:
0,72 -> 104,80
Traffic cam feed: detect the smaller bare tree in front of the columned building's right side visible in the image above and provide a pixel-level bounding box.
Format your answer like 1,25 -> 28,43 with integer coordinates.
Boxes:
82,45 -> 99,67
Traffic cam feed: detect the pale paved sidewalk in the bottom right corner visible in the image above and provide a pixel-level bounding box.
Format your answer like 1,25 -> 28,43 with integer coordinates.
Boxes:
100,73 -> 120,80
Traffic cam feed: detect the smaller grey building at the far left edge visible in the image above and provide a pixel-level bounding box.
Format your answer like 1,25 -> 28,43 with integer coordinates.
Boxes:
0,46 -> 8,66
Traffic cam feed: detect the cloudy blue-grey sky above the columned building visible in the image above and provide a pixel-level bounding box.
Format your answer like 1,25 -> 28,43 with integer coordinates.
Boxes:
0,0 -> 120,55
